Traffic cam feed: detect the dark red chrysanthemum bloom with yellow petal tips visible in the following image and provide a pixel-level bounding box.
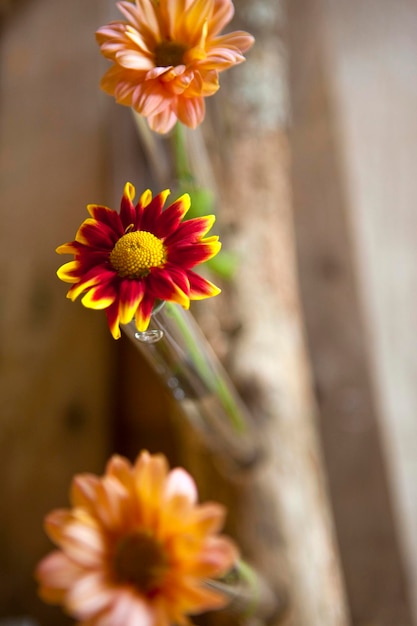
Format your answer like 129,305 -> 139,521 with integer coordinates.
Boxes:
57,183 -> 221,339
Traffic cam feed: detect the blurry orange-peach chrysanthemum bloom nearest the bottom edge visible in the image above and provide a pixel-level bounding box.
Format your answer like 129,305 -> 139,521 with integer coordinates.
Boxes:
36,452 -> 237,626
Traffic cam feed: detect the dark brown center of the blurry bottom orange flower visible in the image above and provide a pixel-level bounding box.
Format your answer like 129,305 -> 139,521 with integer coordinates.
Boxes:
113,532 -> 168,593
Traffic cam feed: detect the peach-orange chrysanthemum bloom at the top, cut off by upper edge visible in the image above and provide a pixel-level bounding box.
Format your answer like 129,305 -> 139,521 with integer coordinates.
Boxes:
97,0 -> 254,133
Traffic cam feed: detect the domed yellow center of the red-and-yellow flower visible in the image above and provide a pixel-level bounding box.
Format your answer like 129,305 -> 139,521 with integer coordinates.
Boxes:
110,230 -> 166,278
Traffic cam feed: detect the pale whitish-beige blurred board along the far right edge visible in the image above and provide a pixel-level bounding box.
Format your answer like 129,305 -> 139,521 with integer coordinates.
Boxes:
321,0 -> 417,624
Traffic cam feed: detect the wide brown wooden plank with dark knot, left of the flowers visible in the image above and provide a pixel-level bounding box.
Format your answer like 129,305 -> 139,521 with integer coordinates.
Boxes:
0,0 -> 111,626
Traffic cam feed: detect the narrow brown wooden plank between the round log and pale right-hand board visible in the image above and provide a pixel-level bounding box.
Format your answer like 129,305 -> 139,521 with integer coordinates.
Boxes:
289,1 -> 412,626
